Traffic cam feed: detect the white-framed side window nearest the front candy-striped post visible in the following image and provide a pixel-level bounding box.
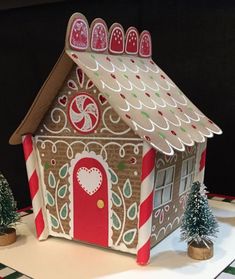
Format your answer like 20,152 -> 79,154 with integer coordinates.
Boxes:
153,166 -> 175,208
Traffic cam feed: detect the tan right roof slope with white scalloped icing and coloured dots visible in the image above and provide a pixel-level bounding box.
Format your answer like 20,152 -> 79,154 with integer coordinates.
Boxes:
66,50 -> 222,155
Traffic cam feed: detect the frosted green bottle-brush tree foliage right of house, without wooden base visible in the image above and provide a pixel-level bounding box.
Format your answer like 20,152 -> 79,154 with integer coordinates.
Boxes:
181,181 -> 218,246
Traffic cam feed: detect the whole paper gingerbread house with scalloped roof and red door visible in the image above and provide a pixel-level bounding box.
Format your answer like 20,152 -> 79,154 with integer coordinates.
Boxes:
10,13 -> 221,264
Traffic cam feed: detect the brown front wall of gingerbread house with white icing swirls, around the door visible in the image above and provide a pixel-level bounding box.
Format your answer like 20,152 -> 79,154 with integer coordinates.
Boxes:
35,66 -> 142,250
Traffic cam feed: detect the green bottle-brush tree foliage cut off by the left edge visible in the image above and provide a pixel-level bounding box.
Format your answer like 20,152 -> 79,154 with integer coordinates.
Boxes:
0,172 -> 20,234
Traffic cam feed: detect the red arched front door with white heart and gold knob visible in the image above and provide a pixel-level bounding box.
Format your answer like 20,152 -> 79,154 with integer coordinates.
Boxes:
73,157 -> 108,247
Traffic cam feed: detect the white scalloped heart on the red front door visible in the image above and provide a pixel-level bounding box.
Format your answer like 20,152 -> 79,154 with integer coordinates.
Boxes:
77,167 -> 103,196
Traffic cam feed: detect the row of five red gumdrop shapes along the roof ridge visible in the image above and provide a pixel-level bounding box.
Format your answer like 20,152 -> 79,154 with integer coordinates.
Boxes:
65,13 -> 152,58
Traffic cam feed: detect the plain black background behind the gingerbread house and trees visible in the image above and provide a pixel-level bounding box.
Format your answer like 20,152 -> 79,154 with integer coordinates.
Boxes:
0,0 -> 235,208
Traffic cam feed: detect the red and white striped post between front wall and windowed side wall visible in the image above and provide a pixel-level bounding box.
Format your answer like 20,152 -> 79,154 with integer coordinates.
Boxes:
137,142 -> 156,265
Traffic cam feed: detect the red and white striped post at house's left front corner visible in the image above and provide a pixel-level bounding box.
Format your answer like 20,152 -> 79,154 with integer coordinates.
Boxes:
22,134 -> 48,240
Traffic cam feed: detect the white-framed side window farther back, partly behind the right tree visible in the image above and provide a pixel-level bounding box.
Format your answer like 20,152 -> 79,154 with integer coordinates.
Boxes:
179,157 -> 195,195
